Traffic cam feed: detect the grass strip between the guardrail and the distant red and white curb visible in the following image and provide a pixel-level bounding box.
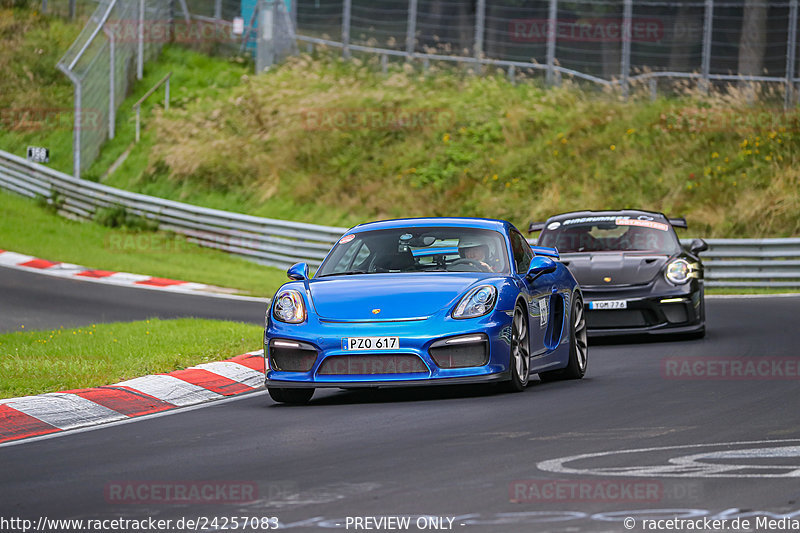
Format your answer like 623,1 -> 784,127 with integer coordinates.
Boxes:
0,191 -> 286,296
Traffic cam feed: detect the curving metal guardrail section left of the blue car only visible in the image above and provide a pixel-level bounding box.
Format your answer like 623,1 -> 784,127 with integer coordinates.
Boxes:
0,150 -> 346,268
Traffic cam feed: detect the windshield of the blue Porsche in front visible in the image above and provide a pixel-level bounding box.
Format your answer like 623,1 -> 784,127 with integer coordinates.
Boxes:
314,227 -> 510,278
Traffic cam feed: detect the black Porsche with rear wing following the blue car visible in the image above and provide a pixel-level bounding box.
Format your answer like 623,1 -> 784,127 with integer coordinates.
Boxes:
529,209 -> 708,338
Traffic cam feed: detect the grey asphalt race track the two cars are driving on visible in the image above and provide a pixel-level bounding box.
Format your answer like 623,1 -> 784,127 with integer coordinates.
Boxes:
0,269 -> 800,533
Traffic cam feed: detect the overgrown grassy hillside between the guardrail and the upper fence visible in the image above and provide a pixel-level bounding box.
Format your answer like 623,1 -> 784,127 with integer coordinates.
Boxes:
103,51 -> 800,237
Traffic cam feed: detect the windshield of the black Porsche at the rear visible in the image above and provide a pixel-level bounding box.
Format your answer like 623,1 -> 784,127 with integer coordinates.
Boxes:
538,216 -> 680,255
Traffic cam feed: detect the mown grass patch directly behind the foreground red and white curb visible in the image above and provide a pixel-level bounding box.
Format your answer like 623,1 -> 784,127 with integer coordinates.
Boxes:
0,318 -> 262,398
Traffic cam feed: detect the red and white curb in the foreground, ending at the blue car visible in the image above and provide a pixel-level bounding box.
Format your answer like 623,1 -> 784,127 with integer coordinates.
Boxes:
0,350 -> 264,443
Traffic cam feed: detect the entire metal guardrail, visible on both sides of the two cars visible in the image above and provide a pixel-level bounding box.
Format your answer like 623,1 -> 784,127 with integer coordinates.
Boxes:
0,150 -> 800,288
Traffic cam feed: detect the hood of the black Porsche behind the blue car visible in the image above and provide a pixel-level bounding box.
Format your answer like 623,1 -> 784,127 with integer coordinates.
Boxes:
561,252 -> 669,287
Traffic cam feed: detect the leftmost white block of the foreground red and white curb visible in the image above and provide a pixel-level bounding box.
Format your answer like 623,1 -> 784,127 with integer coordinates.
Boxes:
4,392 -> 127,429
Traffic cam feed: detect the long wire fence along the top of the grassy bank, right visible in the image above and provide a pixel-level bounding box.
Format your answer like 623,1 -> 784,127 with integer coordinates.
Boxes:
296,0 -> 800,99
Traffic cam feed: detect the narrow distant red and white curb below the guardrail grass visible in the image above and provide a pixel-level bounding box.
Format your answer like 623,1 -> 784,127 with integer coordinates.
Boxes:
0,250 -> 250,300
